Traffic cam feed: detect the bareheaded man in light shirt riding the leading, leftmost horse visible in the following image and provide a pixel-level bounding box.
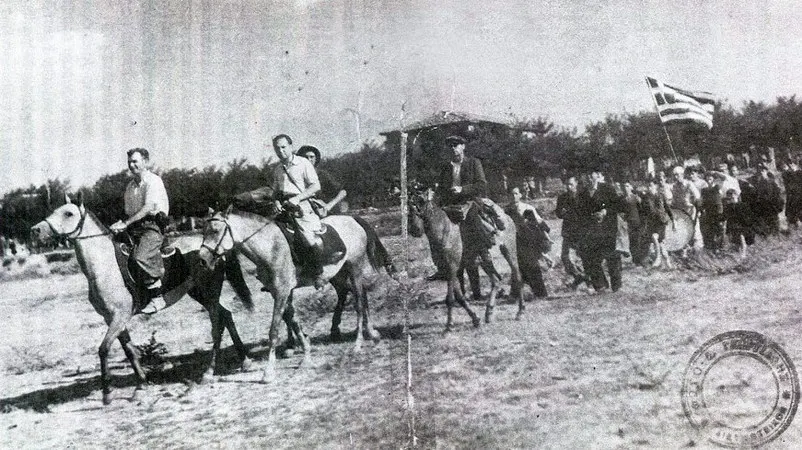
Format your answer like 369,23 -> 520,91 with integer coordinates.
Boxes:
109,148 -> 170,314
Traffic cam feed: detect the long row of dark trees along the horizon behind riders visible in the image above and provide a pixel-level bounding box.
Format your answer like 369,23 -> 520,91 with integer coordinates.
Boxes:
0,96 -> 802,240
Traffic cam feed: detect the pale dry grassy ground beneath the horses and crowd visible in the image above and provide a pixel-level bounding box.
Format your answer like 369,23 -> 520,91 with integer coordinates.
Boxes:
0,222 -> 802,449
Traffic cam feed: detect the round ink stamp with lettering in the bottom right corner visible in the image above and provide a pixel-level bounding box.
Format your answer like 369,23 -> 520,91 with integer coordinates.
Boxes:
681,331 -> 800,447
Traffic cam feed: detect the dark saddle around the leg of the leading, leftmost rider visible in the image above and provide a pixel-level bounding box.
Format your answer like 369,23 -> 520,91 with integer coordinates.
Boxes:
113,237 -> 189,310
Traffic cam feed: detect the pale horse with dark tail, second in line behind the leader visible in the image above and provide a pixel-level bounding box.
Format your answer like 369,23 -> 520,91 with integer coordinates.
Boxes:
199,208 -> 389,381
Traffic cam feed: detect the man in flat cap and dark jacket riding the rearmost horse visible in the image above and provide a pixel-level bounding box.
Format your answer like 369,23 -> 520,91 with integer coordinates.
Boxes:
429,135 -> 500,280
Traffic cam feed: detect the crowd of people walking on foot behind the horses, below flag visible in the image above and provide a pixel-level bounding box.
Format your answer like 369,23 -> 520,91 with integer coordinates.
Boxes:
544,159 -> 802,293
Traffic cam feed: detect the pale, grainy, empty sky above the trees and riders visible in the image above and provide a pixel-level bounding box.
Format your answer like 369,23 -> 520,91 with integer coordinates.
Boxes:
0,0 -> 802,194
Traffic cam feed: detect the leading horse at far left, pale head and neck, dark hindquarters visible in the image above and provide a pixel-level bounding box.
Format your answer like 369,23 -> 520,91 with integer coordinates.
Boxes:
31,198 -> 252,404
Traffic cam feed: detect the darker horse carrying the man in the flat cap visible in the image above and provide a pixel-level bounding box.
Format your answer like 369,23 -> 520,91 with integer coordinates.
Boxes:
408,189 -> 524,331
